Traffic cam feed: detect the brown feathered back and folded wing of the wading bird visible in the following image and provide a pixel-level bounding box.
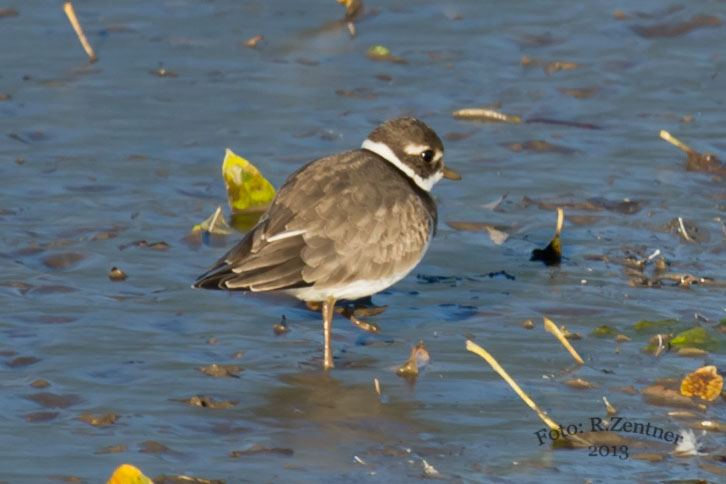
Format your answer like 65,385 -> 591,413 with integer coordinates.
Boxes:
195,150 -> 436,291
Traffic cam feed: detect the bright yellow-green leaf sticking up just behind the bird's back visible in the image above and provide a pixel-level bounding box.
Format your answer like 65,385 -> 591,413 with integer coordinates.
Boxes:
222,148 -> 275,211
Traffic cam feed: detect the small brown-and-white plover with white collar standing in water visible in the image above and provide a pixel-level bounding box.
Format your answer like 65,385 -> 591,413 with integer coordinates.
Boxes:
193,117 -> 461,371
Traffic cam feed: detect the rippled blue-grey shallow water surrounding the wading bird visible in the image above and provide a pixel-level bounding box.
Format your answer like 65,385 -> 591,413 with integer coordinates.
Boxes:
0,0 -> 726,483
